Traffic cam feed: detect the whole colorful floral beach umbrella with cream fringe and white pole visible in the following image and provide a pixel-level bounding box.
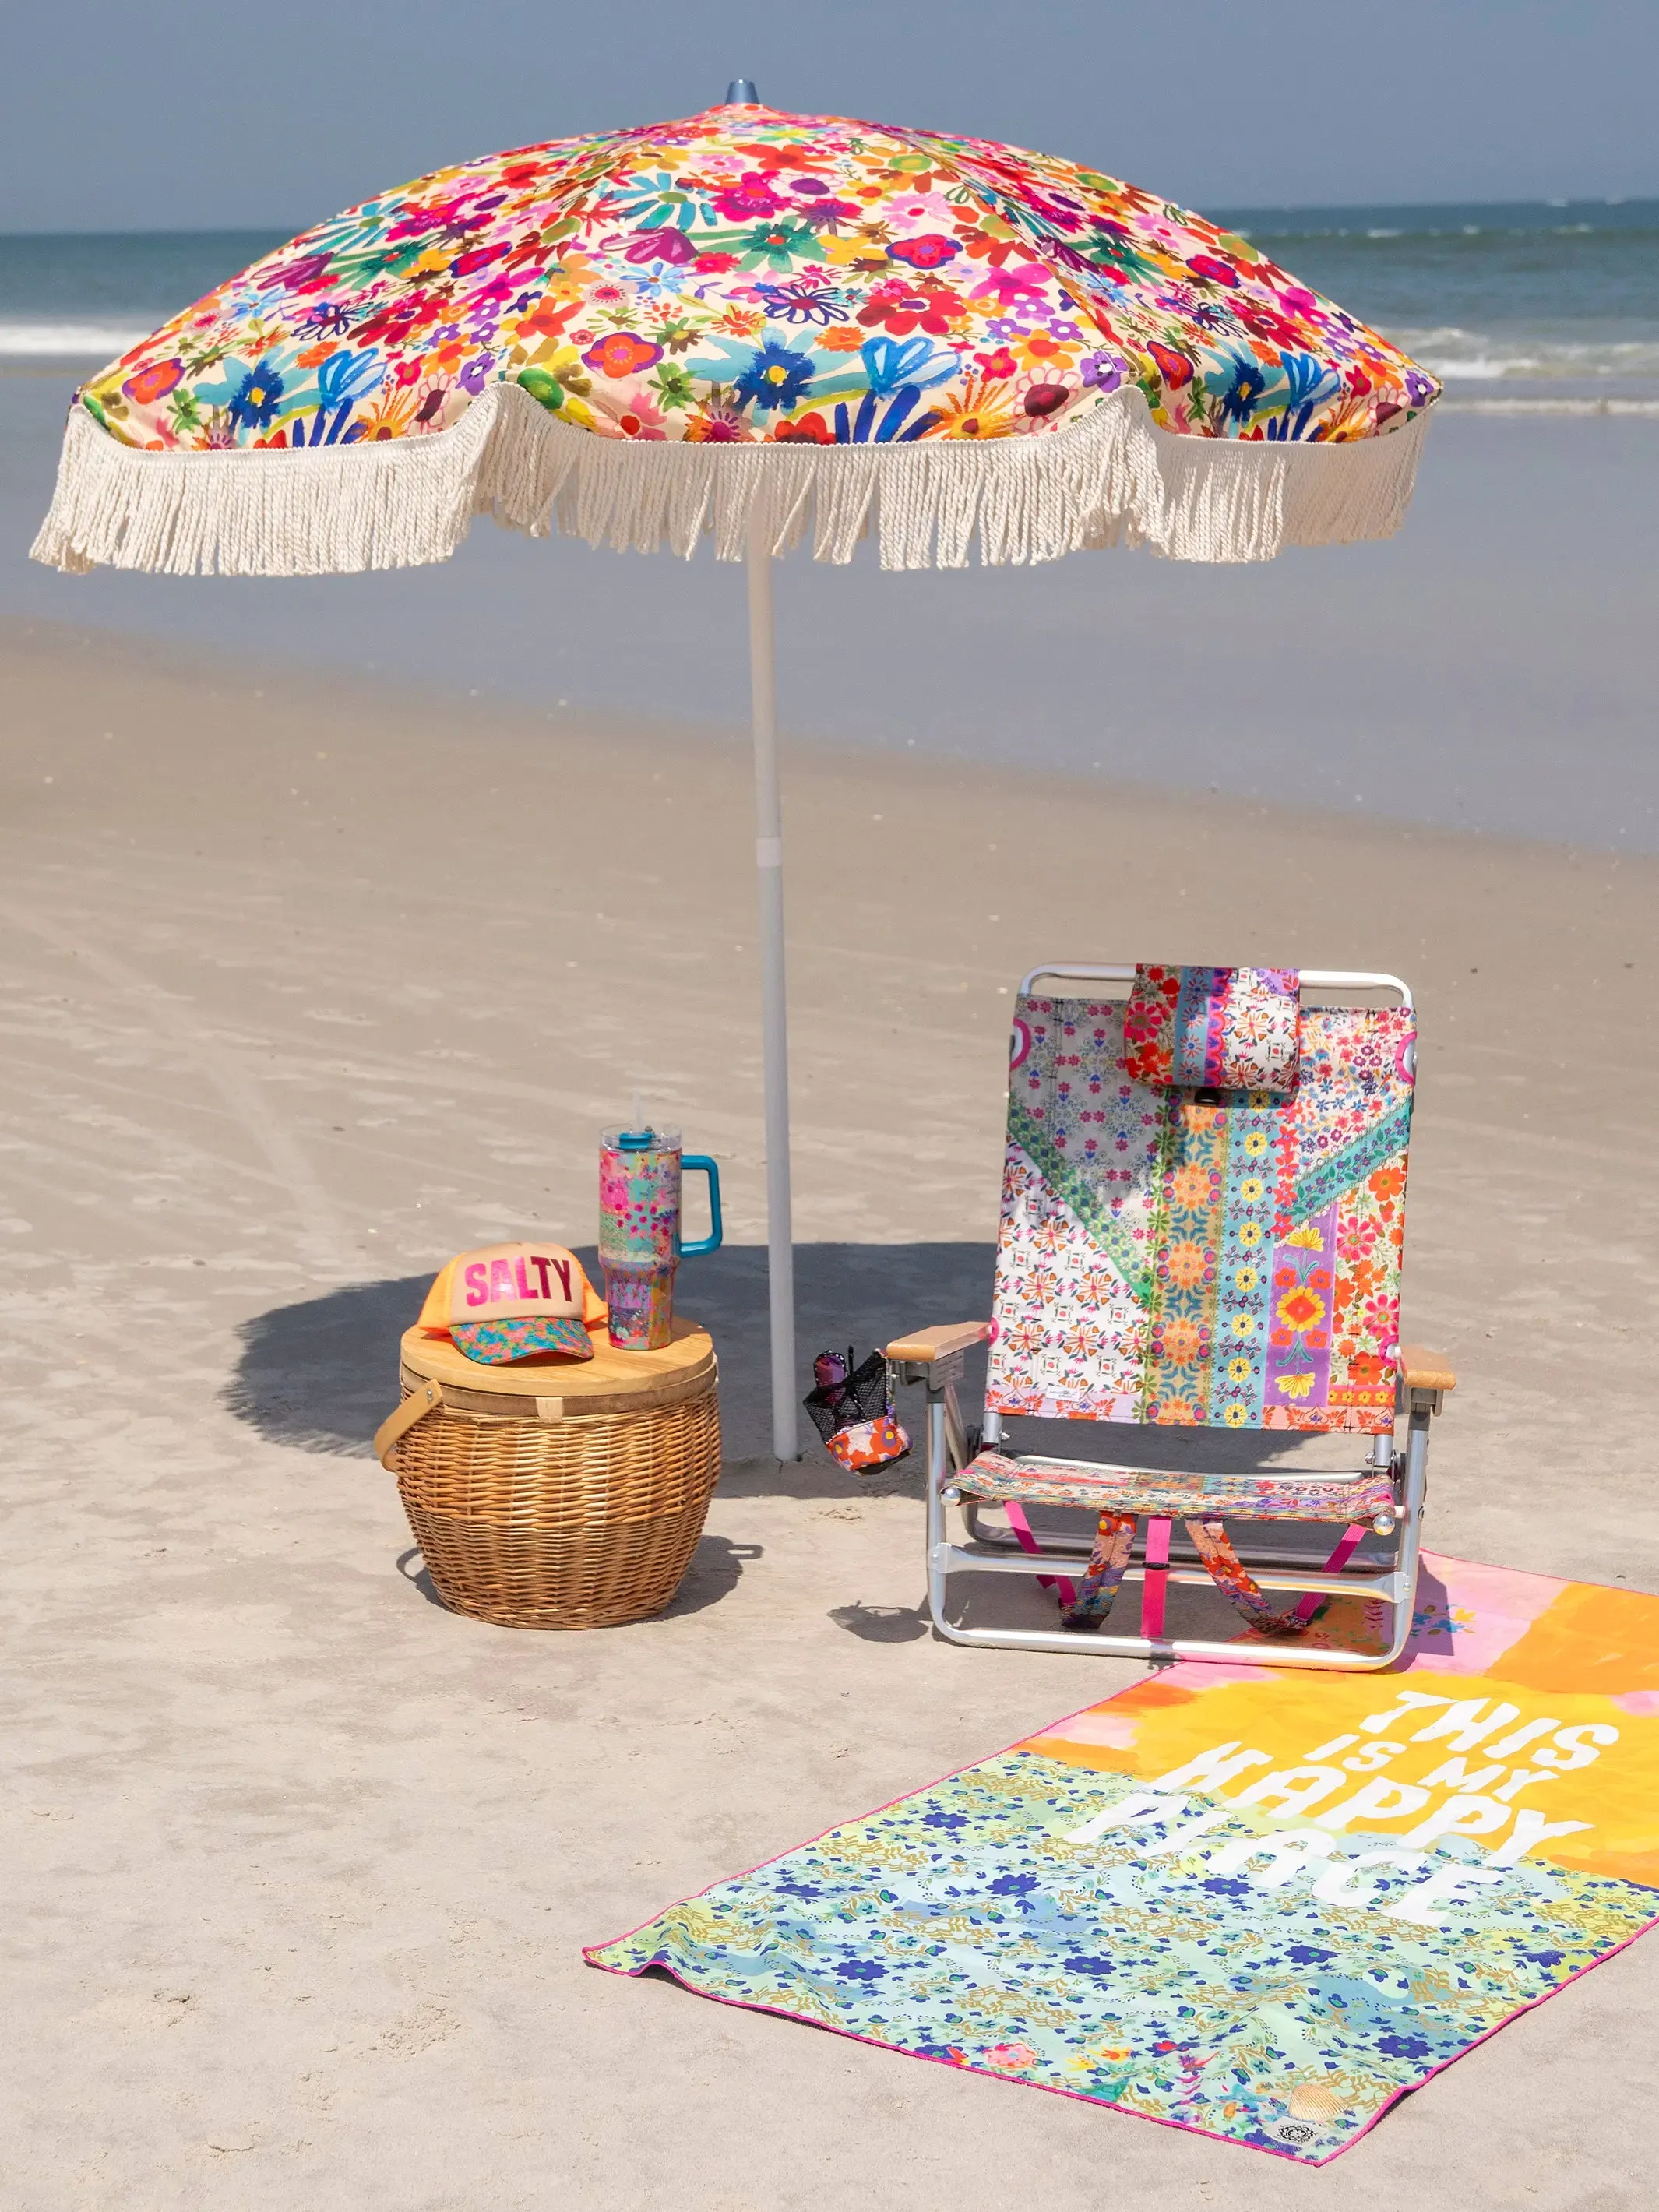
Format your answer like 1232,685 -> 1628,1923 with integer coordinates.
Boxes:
33,82 -> 1438,1458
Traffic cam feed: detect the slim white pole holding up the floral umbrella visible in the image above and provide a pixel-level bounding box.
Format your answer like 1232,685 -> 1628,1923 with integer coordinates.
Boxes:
748,502 -> 801,1460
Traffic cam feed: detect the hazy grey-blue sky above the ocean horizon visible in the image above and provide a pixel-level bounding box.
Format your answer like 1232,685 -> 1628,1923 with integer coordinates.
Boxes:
0,0 -> 1659,232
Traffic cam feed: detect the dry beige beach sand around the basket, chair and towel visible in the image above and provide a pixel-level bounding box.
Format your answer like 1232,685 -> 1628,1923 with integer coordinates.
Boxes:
0,624 -> 1659,2212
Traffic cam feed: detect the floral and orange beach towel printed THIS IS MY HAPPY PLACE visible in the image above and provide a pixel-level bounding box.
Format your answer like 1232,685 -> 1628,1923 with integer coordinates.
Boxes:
586,1553 -> 1659,2165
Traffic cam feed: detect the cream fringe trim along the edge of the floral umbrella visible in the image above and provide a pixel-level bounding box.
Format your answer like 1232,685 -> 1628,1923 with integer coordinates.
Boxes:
33,385 -> 1427,575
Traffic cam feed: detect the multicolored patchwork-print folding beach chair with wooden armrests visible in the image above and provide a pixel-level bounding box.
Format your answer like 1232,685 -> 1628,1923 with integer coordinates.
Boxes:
887,967 -> 1456,1668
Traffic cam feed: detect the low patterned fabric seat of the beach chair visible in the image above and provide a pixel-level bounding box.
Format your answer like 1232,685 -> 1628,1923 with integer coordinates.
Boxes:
951,1451 -> 1398,1522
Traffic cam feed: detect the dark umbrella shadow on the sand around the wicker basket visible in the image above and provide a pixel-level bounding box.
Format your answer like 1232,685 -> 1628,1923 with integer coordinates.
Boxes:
224,1243 -> 995,1498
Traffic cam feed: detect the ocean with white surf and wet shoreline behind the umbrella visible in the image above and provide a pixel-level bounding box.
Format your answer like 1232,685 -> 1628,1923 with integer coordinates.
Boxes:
0,213 -> 1659,851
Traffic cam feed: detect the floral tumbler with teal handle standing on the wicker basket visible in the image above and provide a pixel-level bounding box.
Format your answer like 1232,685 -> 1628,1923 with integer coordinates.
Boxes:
600,1128 -> 721,1351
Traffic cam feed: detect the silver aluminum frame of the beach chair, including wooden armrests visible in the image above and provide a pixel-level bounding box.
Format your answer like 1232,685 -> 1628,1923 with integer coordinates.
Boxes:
887,962 -> 1456,1672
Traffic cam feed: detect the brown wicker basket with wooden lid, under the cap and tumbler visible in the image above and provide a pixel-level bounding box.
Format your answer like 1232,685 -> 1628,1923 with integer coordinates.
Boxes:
374,1320 -> 721,1628
